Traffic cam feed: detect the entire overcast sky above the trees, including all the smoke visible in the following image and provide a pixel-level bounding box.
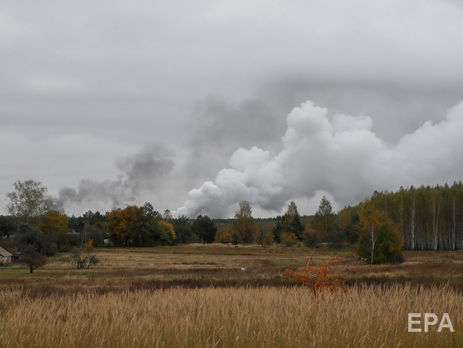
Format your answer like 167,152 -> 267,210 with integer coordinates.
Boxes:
0,0 -> 463,217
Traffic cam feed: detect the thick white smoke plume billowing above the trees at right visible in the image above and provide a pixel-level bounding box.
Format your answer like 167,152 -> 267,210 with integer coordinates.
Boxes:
177,101 -> 463,217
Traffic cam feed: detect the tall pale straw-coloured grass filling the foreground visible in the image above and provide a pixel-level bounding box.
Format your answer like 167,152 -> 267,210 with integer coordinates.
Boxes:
0,286 -> 463,347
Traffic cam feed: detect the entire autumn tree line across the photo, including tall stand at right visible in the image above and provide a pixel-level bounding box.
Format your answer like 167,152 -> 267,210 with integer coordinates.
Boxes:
0,180 -> 463,271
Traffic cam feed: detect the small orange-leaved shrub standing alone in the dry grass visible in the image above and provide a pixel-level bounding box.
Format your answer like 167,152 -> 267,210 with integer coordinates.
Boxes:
283,256 -> 343,294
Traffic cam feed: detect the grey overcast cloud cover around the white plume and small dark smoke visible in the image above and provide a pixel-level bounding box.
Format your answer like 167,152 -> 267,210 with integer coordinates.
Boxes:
0,0 -> 463,216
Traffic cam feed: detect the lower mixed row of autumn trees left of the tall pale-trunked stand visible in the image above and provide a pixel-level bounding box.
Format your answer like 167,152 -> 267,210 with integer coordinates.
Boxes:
0,180 -> 396,266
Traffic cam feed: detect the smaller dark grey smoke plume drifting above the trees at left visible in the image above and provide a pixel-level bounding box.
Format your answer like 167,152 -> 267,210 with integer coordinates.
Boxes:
54,146 -> 174,209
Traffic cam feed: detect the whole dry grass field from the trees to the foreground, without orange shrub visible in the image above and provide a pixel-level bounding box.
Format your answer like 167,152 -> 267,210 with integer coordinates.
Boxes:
0,245 -> 463,347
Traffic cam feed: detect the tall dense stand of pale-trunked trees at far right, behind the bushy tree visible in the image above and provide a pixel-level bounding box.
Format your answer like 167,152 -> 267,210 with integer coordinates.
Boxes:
338,181 -> 463,250
